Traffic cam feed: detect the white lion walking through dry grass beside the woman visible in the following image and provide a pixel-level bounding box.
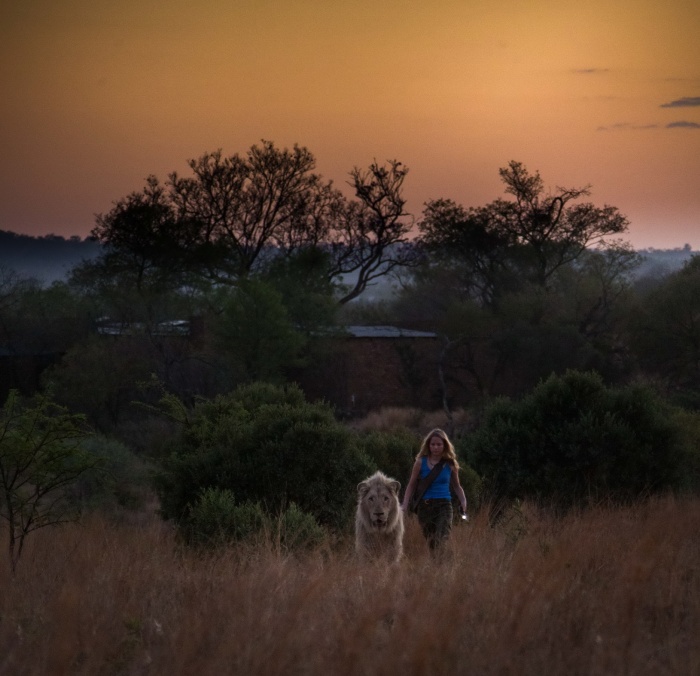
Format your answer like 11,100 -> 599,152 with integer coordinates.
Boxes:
355,472 -> 404,563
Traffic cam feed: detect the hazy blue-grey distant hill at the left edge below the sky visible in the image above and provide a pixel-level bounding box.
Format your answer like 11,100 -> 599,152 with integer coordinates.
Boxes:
0,230 -> 102,284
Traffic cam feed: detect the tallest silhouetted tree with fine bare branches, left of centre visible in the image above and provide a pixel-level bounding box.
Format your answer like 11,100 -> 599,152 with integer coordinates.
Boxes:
168,141 -> 342,282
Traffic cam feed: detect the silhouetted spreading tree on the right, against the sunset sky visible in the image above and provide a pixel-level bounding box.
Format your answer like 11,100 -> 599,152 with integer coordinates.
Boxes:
419,161 -> 629,302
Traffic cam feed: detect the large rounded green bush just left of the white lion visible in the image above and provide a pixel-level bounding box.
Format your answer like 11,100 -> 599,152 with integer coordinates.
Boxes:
157,384 -> 374,528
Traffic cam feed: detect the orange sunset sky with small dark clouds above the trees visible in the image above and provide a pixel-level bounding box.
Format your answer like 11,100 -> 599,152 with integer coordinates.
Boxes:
0,0 -> 700,249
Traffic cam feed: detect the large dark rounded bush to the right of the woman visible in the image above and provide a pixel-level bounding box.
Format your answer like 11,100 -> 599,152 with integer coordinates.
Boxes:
467,371 -> 691,507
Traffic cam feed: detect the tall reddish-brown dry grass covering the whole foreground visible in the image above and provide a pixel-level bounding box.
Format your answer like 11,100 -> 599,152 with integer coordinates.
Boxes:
0,498 -> 700,676
